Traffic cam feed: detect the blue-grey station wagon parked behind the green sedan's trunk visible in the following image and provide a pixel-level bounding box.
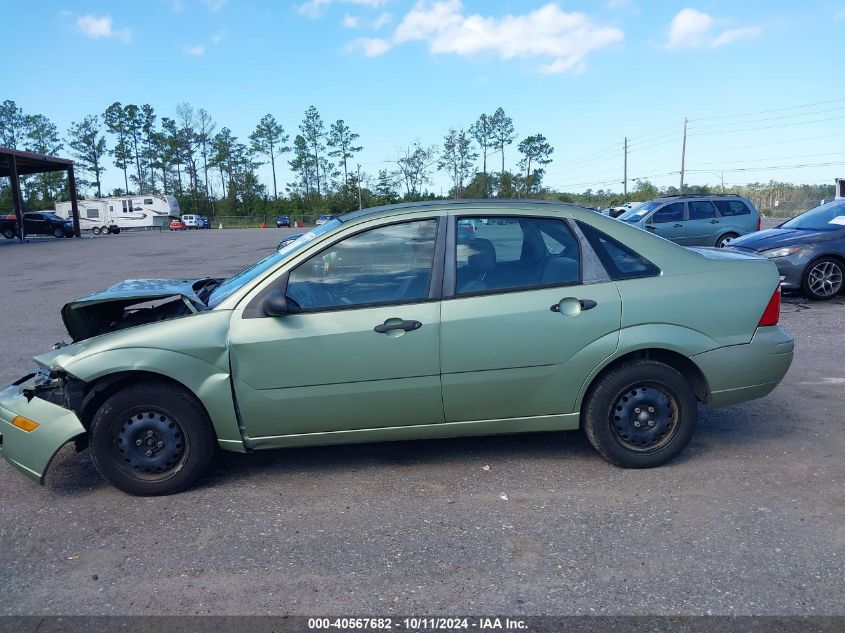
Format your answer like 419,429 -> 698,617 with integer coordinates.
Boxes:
617,194 -> 760,247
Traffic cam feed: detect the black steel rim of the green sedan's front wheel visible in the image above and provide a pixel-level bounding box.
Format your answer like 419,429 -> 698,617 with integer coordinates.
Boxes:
114,411 -> 190,480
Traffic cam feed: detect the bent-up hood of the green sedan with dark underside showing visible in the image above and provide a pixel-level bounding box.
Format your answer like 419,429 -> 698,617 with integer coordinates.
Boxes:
62,278 -> 217,342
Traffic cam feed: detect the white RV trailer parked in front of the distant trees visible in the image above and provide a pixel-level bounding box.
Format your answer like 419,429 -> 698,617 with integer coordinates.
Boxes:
56,194 -> 180,235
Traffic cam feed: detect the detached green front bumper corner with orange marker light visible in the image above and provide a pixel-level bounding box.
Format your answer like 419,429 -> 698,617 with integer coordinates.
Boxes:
0,378 -> 85,484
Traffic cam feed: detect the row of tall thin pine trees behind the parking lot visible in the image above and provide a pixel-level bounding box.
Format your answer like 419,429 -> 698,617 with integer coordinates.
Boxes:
0,100 -> 554,214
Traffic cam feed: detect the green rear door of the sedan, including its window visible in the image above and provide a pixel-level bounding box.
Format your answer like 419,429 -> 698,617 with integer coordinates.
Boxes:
440,215 -> 621,422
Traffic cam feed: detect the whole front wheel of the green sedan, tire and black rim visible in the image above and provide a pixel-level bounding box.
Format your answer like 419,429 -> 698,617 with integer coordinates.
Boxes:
90,382 -> 216,496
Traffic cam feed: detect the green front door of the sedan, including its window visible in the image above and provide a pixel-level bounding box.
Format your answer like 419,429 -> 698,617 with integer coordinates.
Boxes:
230,218 -> 445,447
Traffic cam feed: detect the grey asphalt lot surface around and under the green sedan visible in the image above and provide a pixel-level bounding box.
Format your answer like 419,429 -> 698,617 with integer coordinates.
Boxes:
0,220 -> 845,615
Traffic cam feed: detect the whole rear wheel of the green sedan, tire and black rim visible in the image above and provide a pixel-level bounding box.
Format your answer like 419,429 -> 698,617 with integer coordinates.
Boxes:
582,360 -> 698,468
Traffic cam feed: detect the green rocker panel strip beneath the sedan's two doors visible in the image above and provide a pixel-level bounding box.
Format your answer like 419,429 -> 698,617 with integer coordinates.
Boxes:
244,413 -> 579,450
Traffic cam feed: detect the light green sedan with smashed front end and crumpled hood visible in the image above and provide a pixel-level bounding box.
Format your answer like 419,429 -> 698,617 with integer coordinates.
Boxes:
0,201 -> 793,495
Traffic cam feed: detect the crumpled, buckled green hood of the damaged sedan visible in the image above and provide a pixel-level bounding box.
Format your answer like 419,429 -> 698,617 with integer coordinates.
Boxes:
62,278 -> 214,341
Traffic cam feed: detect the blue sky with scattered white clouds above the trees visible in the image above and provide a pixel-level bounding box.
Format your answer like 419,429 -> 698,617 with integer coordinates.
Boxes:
0,0 -> 845,191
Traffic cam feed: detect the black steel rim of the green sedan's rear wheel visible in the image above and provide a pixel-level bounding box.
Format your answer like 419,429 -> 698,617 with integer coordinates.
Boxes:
610,383 -> 678,453
